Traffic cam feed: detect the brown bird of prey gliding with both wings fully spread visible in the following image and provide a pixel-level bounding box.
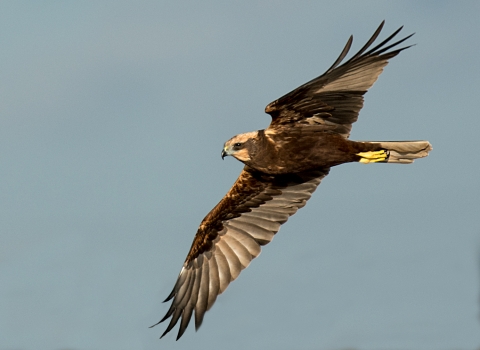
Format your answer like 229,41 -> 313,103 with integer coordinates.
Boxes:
152,22 -> 432,340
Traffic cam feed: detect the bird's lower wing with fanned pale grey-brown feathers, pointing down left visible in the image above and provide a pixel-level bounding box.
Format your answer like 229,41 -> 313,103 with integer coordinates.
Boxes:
152,167 -> 329,340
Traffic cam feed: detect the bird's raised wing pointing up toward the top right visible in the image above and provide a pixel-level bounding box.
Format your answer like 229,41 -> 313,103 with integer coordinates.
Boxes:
265,22 -> 413,137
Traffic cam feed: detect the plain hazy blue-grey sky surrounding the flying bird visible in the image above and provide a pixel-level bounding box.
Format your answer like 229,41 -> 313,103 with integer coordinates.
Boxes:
0,1 -> 480,350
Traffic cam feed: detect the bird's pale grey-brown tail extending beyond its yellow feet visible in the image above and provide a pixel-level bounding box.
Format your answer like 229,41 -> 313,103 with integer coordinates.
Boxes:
375,141 -> 432,164
